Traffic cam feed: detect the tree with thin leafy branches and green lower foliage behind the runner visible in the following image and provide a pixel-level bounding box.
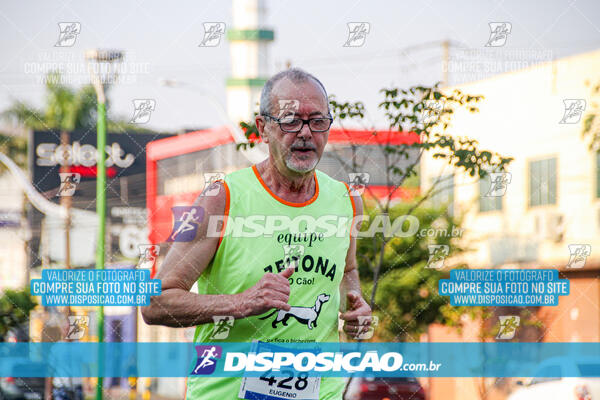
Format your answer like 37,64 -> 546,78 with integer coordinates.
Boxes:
238,85 -> 512,340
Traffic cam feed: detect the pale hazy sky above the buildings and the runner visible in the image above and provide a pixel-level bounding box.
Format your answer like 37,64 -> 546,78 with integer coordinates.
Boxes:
0,0 -> 600,131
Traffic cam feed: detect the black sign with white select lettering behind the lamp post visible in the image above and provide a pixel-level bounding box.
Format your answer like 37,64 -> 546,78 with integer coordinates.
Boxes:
28,130 -> 173,267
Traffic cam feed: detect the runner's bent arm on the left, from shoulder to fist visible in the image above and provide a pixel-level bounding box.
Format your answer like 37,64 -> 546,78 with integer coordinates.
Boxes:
142,182 -> 293,328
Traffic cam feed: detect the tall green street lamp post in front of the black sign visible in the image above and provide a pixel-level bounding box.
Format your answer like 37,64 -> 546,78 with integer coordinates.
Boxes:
85,50 -> 123,400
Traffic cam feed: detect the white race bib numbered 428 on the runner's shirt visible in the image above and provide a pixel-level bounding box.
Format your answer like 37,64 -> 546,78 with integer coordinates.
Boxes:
238,342 -> 321,400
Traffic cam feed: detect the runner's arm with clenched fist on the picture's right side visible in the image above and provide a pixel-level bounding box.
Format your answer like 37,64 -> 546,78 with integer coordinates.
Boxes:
340,191 -> 371,337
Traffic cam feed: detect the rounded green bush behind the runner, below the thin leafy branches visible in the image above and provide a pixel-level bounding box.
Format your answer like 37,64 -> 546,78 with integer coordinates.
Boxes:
357,203 -> 472,341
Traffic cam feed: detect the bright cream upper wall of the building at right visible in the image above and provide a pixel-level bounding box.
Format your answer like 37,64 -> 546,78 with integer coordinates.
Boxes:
422,51 -> 600,267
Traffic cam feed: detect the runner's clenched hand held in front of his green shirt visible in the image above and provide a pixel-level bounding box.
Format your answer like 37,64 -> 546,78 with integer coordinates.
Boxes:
240,268 -> 294,317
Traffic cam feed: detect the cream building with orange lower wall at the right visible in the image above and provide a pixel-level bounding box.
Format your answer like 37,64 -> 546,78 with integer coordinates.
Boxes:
421,51 -> 600,399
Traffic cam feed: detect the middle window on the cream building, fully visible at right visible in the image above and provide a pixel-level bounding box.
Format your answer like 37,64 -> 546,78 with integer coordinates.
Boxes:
529,158 -> 556,207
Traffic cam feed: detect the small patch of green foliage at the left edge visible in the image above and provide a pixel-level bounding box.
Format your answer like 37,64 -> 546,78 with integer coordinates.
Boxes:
0,289 -> 37,341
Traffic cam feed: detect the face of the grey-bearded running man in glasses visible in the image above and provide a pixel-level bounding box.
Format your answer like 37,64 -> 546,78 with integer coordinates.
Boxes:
256,79 -> 329,174
